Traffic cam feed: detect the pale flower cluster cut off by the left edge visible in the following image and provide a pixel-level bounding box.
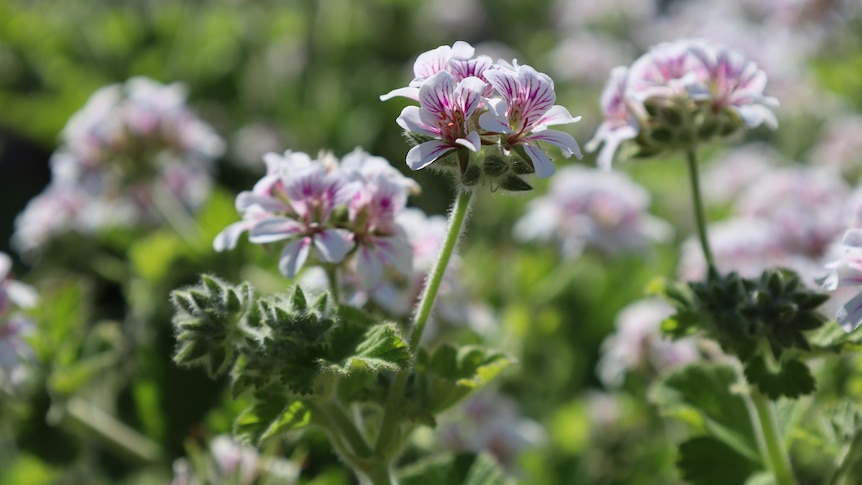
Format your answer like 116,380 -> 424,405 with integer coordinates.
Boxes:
0,253 -> 36,387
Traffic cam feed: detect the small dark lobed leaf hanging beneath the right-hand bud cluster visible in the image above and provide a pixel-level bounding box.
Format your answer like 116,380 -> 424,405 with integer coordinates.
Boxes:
745,355 -> 817,400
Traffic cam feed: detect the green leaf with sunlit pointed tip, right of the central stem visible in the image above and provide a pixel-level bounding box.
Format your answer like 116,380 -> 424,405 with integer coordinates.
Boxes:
417,344 -> 515,416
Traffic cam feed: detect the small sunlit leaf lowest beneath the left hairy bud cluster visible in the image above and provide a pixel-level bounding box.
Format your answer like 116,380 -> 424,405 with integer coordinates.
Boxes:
233,387 -> 311,445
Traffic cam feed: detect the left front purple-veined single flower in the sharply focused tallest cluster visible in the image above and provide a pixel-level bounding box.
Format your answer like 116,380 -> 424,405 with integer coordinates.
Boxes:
396,71 -> 485,170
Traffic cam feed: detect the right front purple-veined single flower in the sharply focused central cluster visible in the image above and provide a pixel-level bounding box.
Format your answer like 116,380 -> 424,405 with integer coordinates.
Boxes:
479,63 -> 581,178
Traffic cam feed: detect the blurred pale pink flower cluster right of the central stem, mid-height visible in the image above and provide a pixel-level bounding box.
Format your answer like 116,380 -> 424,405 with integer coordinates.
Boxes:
514,166 -> 672,256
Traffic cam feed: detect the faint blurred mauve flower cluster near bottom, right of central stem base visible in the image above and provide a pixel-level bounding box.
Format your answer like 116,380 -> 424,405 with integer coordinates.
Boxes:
437,391 -> 547,471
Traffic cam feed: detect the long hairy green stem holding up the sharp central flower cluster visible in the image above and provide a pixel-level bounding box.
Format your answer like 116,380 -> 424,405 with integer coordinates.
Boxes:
374,187 -> 472,457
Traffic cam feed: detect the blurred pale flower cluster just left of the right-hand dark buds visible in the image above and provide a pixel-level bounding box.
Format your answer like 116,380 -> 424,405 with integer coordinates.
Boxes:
597,298 -> 699,387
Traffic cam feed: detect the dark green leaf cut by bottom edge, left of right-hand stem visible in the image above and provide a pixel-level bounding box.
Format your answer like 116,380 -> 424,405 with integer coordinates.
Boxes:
676,436 -> 760,485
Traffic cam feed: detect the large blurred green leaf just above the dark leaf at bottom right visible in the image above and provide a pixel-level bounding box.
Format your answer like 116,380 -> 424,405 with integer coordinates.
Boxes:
649,363 -> 759,461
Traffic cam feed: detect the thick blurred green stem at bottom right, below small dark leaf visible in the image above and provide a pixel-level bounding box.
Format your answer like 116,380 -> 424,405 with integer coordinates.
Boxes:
748,389 -> 796,485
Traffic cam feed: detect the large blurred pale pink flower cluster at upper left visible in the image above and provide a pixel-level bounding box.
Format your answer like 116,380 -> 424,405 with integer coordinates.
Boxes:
13,77 -> 224,253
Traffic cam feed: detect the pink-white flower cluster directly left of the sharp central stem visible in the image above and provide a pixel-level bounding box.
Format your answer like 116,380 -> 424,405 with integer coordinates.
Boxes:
213,149 -> 418,290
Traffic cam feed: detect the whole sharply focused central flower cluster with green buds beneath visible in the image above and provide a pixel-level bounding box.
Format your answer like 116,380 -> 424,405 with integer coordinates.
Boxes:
381,41 -> 581,182
